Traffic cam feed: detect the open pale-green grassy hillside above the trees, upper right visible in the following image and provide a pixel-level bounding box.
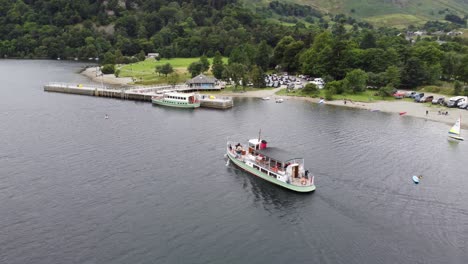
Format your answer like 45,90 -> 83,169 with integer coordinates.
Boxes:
263,0 -> 468,26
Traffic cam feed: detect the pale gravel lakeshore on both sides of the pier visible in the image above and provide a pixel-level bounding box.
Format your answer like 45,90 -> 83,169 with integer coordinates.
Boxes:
82,67 -> 468,129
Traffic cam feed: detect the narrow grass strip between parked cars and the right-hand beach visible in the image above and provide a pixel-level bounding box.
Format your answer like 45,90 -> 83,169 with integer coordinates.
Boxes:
276,89 -> 395,103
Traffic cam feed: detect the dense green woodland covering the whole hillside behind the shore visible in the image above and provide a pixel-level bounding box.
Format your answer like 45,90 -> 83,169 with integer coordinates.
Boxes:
0,0 -> 468,93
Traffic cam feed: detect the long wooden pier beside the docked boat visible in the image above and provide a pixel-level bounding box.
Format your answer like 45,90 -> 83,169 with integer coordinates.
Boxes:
44,82 -> 234,109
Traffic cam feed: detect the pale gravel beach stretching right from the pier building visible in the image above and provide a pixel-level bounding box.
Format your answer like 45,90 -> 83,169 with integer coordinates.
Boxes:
223,88 -> 468,129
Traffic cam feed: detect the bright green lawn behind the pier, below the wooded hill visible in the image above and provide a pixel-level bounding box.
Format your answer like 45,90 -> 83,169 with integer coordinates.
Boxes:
118,58 -> 227,85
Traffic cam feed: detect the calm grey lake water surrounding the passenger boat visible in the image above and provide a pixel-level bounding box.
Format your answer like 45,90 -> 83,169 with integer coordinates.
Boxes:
0,60 -> 468,264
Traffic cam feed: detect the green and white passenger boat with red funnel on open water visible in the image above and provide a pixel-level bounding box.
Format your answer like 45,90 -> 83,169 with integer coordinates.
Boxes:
226,137 -> 315,193
